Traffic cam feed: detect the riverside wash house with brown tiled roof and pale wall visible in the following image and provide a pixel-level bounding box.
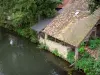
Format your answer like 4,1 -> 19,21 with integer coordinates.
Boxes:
39,0 -> 100,59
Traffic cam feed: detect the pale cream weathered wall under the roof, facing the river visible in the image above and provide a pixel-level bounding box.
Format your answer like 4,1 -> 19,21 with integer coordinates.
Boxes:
39,37 -> 71,60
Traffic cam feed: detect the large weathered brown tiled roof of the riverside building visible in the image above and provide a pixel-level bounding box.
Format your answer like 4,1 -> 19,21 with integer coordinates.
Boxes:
43,0 -> 100,47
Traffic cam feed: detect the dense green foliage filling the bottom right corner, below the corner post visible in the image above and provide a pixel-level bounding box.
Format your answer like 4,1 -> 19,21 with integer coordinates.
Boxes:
75,53 -> 100,75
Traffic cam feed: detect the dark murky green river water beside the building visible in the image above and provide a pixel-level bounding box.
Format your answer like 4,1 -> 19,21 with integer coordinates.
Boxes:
0,29 -> 85,75
